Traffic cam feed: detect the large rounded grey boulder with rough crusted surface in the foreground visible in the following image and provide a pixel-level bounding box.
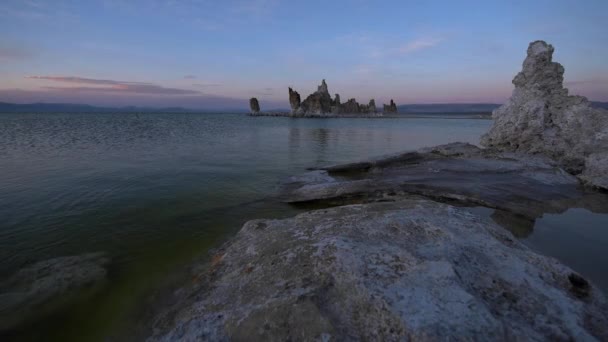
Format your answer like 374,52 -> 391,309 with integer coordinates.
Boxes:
150,200 -> 608,341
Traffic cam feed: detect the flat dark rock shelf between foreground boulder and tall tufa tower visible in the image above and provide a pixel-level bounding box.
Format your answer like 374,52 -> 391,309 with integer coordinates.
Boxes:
281,143 -> 608,227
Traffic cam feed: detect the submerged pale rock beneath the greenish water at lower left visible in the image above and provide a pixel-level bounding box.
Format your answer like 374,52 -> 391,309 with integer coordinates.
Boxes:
0,253 -> 110,331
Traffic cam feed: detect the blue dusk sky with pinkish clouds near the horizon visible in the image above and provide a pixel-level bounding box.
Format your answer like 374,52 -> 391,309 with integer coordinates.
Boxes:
0,0 -> 608,109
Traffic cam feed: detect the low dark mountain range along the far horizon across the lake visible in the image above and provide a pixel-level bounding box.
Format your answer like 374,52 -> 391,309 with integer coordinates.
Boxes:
0,102 -> 608,114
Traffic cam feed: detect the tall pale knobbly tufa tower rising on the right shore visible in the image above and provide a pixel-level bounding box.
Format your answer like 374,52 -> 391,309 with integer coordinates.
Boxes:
482,41 -> 608,189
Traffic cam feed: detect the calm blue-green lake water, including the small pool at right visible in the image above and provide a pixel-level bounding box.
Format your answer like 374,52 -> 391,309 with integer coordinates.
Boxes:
0,113 -> 608,340
